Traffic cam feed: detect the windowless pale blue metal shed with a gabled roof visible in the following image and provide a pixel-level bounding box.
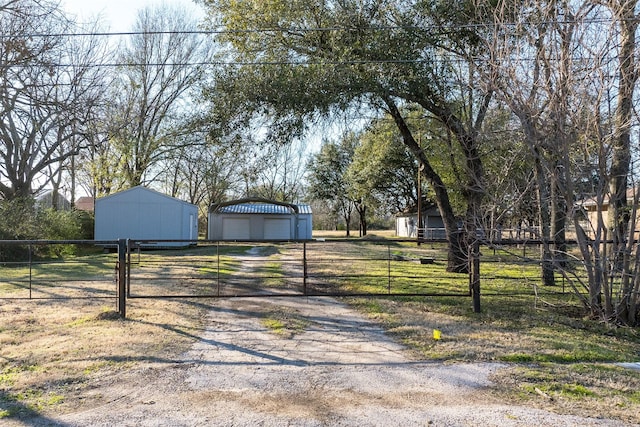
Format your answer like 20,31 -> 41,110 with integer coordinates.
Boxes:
95,186 -> 198,246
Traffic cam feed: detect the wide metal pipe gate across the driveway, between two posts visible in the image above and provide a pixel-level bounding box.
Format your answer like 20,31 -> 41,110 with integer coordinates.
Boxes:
126,240 -> 469,298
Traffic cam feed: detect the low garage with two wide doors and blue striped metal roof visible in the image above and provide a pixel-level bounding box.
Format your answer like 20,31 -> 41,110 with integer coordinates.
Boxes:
209,198 -> 313,241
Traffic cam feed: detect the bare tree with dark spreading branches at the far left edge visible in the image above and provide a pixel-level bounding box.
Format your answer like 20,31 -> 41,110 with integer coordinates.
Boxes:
0,0 -> 107,199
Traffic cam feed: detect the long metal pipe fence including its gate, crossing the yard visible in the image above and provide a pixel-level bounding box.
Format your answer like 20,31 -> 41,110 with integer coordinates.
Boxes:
0,239 -> 580,317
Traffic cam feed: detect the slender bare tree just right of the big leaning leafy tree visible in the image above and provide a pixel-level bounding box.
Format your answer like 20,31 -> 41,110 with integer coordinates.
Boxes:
488,0 -> 590,285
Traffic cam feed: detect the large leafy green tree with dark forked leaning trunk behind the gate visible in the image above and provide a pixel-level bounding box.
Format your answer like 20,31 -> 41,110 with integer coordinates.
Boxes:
202,0 -> 492,272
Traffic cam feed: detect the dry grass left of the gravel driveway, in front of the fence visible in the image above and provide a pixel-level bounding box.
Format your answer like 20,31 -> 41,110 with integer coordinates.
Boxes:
0,300 -> 207,420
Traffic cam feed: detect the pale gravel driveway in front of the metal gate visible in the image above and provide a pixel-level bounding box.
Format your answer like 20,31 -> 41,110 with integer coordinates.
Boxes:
29,298 -> 623,426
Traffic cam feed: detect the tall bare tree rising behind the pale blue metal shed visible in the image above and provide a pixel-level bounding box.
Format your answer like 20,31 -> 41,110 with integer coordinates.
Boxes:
109,5 -> 208,186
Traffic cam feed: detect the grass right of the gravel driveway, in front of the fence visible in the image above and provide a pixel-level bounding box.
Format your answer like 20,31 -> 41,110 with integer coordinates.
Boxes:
349,298 -> 640,424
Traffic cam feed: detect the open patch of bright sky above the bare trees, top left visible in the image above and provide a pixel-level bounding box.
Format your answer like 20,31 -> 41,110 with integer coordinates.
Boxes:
62,0 -> 204,33
